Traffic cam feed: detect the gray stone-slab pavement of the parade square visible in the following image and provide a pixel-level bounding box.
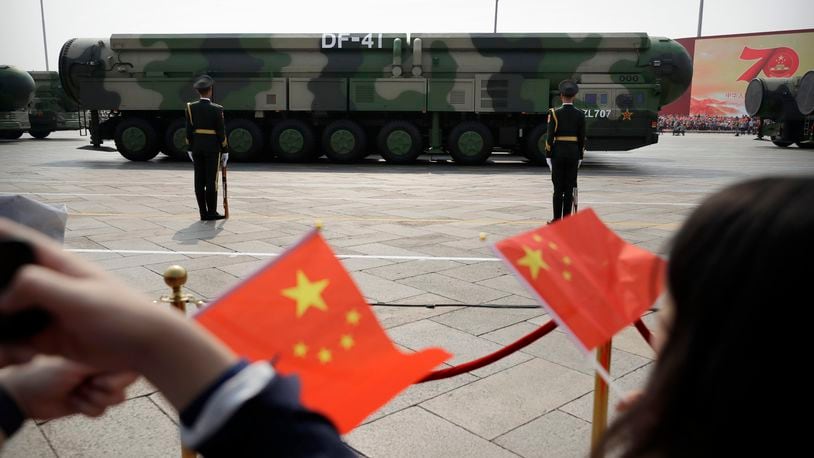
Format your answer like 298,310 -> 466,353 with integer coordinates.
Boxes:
0,133 -> 814,457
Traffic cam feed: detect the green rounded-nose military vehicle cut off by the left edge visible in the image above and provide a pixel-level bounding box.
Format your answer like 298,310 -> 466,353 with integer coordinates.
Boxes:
0,65 -> 34,140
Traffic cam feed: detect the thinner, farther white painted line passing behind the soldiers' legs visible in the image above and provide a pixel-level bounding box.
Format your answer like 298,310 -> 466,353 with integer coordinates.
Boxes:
0,190 -> 698,207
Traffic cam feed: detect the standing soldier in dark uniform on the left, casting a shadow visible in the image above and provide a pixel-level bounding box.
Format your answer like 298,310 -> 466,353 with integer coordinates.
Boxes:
185,75 -> 229,221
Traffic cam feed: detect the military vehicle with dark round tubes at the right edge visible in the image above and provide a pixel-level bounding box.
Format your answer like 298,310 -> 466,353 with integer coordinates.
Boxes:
744,70 -> 814,148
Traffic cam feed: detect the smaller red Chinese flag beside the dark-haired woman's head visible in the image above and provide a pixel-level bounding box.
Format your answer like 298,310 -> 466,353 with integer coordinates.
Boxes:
495,209 -> 666,351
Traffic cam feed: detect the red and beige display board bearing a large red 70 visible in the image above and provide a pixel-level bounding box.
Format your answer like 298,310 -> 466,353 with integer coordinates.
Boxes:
661,29 -> 814,116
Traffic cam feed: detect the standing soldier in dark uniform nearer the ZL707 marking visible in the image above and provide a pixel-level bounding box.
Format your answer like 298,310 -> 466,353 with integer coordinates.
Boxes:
545,80 -> 585,222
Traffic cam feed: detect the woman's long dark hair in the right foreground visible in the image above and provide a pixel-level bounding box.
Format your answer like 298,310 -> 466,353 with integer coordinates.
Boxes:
594,177 -> 814,457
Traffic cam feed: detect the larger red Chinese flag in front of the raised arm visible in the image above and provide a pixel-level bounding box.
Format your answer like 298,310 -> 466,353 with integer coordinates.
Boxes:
197,231 -> 450,433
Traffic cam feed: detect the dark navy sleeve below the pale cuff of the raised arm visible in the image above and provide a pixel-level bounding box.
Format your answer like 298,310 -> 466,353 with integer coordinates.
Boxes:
197,374 -> 356,458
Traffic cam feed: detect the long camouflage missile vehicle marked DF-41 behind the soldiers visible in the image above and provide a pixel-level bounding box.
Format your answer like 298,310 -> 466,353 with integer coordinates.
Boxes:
59,33 -> 692,164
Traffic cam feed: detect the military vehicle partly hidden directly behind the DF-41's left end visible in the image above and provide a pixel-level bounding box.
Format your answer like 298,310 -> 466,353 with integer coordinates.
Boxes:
28,72 -> 80,138
